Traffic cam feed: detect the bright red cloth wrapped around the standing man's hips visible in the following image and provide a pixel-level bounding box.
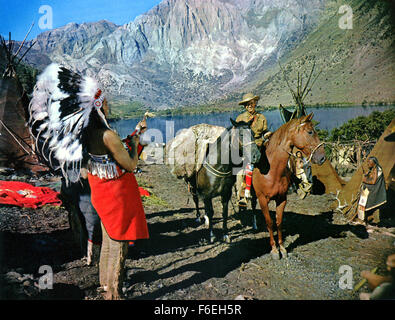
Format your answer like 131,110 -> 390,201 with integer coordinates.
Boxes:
88,172 -> 149,241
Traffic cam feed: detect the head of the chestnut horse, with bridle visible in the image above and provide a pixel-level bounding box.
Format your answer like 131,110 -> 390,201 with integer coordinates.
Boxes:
292,113 -> 325,165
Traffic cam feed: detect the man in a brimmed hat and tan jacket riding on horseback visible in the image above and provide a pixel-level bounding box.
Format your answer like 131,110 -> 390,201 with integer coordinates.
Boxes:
236,93 -> 272,206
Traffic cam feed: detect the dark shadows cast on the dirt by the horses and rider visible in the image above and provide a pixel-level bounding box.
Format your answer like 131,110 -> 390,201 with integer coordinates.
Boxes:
127,205 -> 368,299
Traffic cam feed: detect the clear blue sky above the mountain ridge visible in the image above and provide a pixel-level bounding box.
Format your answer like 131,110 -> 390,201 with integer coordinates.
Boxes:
0,0 -> 161,40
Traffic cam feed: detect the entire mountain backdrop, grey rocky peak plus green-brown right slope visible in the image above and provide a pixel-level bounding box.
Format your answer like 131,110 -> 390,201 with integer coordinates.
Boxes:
17,0 -> 395,109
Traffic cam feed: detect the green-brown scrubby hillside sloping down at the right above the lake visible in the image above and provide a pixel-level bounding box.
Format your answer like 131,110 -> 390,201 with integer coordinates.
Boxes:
245,0 -> 395,105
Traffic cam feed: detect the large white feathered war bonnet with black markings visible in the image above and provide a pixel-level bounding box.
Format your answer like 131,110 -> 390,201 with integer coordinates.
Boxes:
29,63 -> 110,182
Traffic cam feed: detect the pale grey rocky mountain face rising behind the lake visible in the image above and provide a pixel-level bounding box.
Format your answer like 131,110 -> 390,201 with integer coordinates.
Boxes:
23,0 -> 325,108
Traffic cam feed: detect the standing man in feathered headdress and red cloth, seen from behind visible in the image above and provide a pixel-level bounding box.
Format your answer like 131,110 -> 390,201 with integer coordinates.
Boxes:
29,63 -> 149,299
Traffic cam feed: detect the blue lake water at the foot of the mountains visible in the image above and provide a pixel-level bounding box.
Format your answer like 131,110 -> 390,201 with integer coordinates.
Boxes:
111,106 -> 394,142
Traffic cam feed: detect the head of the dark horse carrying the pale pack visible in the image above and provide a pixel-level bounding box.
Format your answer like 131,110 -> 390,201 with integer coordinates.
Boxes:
230,118 -> 261,163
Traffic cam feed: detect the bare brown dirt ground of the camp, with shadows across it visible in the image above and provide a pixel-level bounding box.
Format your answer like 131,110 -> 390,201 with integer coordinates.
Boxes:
0,165 -> 395,300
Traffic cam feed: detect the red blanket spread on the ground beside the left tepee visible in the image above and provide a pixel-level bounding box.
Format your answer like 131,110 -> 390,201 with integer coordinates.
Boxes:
0,181 -> 62,208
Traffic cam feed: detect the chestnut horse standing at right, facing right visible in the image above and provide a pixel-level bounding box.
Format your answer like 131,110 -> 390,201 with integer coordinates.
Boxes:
252,113 -> 325,260
